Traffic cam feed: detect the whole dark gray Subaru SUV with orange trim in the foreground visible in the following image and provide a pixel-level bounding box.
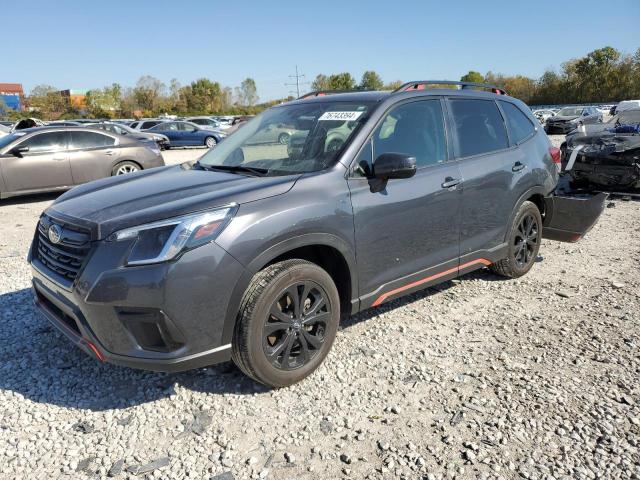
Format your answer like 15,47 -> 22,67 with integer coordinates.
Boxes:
29,81 -> 604,387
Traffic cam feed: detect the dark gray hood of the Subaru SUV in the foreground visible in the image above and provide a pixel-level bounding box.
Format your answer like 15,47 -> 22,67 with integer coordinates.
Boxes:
45,164 -> 300,240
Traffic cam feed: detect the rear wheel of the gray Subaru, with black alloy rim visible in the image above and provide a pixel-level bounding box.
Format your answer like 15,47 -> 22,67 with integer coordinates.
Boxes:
489,201 -> 542,278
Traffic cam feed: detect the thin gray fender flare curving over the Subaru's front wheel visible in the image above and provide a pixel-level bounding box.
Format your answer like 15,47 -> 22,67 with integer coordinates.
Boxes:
222,233 -> 358,344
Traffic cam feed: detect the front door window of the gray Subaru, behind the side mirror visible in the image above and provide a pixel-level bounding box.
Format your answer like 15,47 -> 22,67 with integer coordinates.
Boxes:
373,100 -> 447,168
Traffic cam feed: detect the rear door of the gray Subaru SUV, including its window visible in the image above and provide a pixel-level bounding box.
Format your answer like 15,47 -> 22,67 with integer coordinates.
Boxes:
448,97 -> 534,263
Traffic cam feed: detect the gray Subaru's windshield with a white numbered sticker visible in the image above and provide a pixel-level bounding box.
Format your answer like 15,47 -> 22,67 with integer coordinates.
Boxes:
198,102 -> 372,176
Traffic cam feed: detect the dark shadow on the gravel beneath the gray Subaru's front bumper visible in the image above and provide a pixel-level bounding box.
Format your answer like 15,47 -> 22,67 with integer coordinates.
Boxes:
0,288 -> 268,411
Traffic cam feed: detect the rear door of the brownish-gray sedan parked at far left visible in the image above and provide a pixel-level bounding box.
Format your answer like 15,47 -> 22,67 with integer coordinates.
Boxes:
69,130 -> 120,185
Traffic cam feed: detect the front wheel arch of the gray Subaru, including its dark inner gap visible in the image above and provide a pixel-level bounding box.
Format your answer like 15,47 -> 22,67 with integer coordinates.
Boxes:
223,233 -> 358,343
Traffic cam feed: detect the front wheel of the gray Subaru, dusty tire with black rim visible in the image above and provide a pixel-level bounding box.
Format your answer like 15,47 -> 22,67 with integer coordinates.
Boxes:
232,259 -> 340,387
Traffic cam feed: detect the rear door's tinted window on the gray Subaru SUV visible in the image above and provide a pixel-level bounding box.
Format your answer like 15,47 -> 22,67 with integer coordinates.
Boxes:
450,99 -> 508,157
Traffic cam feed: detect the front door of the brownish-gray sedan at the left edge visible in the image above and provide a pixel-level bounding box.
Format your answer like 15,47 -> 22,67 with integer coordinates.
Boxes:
1,131 -> 73,192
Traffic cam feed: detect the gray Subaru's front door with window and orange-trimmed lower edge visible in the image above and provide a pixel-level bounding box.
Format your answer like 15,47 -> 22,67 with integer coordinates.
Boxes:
348,99 -> 462,308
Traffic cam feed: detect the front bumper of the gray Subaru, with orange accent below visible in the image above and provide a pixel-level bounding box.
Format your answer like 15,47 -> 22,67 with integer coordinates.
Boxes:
30,238 -> 244,372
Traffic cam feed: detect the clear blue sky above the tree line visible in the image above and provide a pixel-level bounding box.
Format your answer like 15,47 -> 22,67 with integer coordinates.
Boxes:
6,0 -> 640,100
